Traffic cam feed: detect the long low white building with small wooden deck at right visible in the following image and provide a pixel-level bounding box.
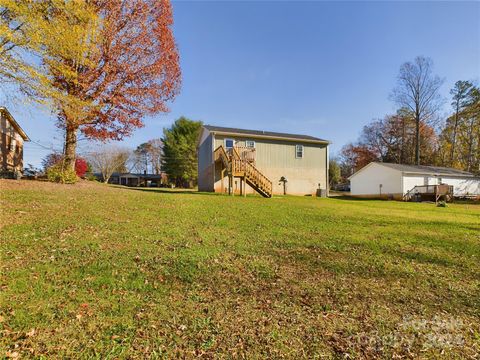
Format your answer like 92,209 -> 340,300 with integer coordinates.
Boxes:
349,162 -> 480,200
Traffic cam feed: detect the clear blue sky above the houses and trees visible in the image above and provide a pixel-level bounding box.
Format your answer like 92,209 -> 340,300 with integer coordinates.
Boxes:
0,1 -> 480,165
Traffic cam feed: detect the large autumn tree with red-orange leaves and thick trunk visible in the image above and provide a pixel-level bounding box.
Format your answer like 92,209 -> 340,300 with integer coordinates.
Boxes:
46,0 -> 181,168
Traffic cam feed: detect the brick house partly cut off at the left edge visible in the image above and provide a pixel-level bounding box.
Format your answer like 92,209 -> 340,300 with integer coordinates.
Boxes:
0,107 -> 30,178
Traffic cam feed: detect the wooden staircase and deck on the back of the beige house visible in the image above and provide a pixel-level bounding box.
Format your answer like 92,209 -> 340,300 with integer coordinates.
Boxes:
214,145 -> 273,198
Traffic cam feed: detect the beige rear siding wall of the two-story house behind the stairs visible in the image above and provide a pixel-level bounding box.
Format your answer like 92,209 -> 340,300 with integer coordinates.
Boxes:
214,134 -> 328,195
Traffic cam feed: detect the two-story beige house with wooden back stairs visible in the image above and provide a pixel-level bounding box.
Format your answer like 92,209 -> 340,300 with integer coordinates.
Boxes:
197,125 -> 329,197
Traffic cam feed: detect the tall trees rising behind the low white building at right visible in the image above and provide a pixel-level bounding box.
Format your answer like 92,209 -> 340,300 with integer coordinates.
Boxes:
331,57 -> 480,182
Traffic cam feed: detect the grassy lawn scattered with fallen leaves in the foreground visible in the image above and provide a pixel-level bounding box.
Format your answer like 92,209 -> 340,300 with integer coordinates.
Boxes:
0,181 -> 480,359
